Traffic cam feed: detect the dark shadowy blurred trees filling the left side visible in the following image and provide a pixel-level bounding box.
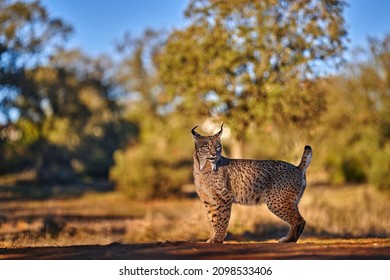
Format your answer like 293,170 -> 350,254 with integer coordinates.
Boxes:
0,1 -> 138,182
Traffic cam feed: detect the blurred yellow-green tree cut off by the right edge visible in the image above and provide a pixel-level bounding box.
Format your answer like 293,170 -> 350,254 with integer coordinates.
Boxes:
348,34 -> 390,190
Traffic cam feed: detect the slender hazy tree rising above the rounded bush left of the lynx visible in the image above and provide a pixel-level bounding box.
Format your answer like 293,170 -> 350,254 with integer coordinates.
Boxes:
115,30 -> 165,140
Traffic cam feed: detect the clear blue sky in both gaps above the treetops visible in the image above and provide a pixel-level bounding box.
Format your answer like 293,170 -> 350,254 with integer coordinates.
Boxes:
41,0 -> 390,56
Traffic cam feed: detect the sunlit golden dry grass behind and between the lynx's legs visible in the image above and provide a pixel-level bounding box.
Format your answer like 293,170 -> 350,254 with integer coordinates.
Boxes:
0,186 -> 390,248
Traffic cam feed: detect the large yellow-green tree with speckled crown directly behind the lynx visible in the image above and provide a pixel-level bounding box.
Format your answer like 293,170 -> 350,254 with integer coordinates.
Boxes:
157,0 -> 346,157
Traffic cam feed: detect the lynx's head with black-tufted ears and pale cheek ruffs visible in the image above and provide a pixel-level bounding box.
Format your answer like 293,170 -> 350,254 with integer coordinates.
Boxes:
191,124 -> 223,171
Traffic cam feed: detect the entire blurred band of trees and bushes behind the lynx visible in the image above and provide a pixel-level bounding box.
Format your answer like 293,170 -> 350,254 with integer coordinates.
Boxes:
0,0 -> 390,199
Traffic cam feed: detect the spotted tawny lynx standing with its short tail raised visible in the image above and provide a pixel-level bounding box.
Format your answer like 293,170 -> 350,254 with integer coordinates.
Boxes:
191,124 -> 312,243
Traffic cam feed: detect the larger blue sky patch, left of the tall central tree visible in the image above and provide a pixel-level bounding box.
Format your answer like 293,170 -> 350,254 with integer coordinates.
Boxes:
41,0 -> 189,55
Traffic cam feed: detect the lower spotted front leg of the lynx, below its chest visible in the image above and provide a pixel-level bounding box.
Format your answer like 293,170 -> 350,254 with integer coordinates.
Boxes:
205,202 -> 232,243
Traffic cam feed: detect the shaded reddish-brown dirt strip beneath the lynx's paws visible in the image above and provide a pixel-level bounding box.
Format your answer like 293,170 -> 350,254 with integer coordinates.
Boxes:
0,238 -> 390,260
